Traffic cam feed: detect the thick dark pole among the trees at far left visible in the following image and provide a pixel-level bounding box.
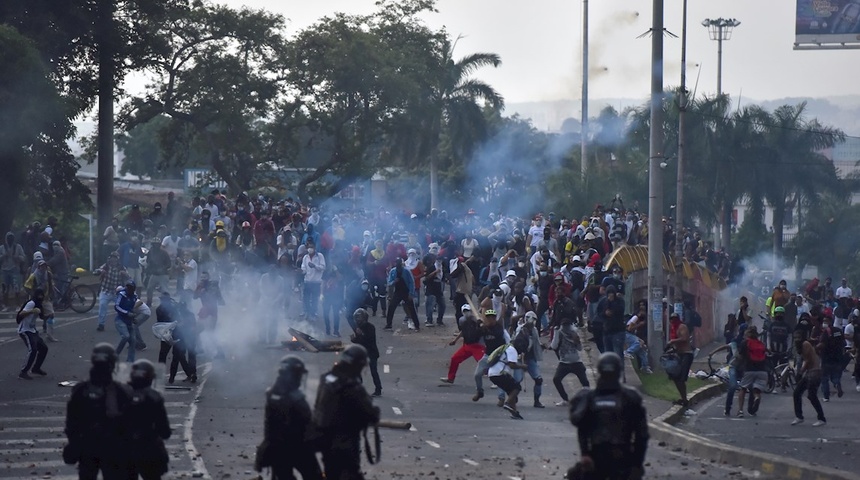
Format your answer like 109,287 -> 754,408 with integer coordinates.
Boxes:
96,0 -> 114,231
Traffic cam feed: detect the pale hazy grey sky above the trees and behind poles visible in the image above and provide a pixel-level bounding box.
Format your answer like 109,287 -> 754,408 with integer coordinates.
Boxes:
222,0 -> 860,102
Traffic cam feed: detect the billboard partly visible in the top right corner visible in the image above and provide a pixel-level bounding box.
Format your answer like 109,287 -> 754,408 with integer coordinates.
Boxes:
795,0 -> 860,48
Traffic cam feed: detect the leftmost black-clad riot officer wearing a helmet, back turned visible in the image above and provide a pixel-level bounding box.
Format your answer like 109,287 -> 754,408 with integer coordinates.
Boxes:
63,343 -> 132,480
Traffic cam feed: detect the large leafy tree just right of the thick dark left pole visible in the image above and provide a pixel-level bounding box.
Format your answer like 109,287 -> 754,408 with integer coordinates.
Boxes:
121,2 -> 286,191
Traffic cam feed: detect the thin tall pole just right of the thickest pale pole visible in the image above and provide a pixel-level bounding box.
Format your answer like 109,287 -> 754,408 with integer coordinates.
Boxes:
675,0 -> 687,312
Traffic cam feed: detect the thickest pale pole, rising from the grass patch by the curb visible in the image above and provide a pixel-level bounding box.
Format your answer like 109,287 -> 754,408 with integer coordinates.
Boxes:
648,0 -> 665,364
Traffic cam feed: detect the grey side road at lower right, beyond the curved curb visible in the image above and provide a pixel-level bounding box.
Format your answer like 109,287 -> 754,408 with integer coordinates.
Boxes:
679,374 -> 860,472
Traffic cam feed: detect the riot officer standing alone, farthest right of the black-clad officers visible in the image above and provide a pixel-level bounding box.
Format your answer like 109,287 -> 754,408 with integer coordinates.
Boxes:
568,352 -> 648,480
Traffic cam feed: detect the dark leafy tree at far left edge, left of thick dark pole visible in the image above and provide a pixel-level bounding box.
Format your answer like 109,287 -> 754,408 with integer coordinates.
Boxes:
0,25 -> 89,231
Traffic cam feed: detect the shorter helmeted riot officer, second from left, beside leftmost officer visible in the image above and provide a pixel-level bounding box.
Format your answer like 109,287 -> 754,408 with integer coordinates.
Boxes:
127,359 -> 171,480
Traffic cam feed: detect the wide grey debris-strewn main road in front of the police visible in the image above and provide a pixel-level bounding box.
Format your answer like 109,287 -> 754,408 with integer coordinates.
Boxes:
0,311 -> 763,480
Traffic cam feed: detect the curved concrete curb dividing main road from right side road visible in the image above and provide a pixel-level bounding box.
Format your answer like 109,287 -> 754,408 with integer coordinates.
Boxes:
648,384 -> 860,480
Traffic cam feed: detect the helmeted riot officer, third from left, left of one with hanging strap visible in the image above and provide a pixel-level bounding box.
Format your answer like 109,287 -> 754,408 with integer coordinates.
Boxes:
254,355 -> 323,480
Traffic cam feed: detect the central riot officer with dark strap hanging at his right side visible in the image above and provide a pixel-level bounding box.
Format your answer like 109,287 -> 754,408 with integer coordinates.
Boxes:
314,345 -> 379,480
